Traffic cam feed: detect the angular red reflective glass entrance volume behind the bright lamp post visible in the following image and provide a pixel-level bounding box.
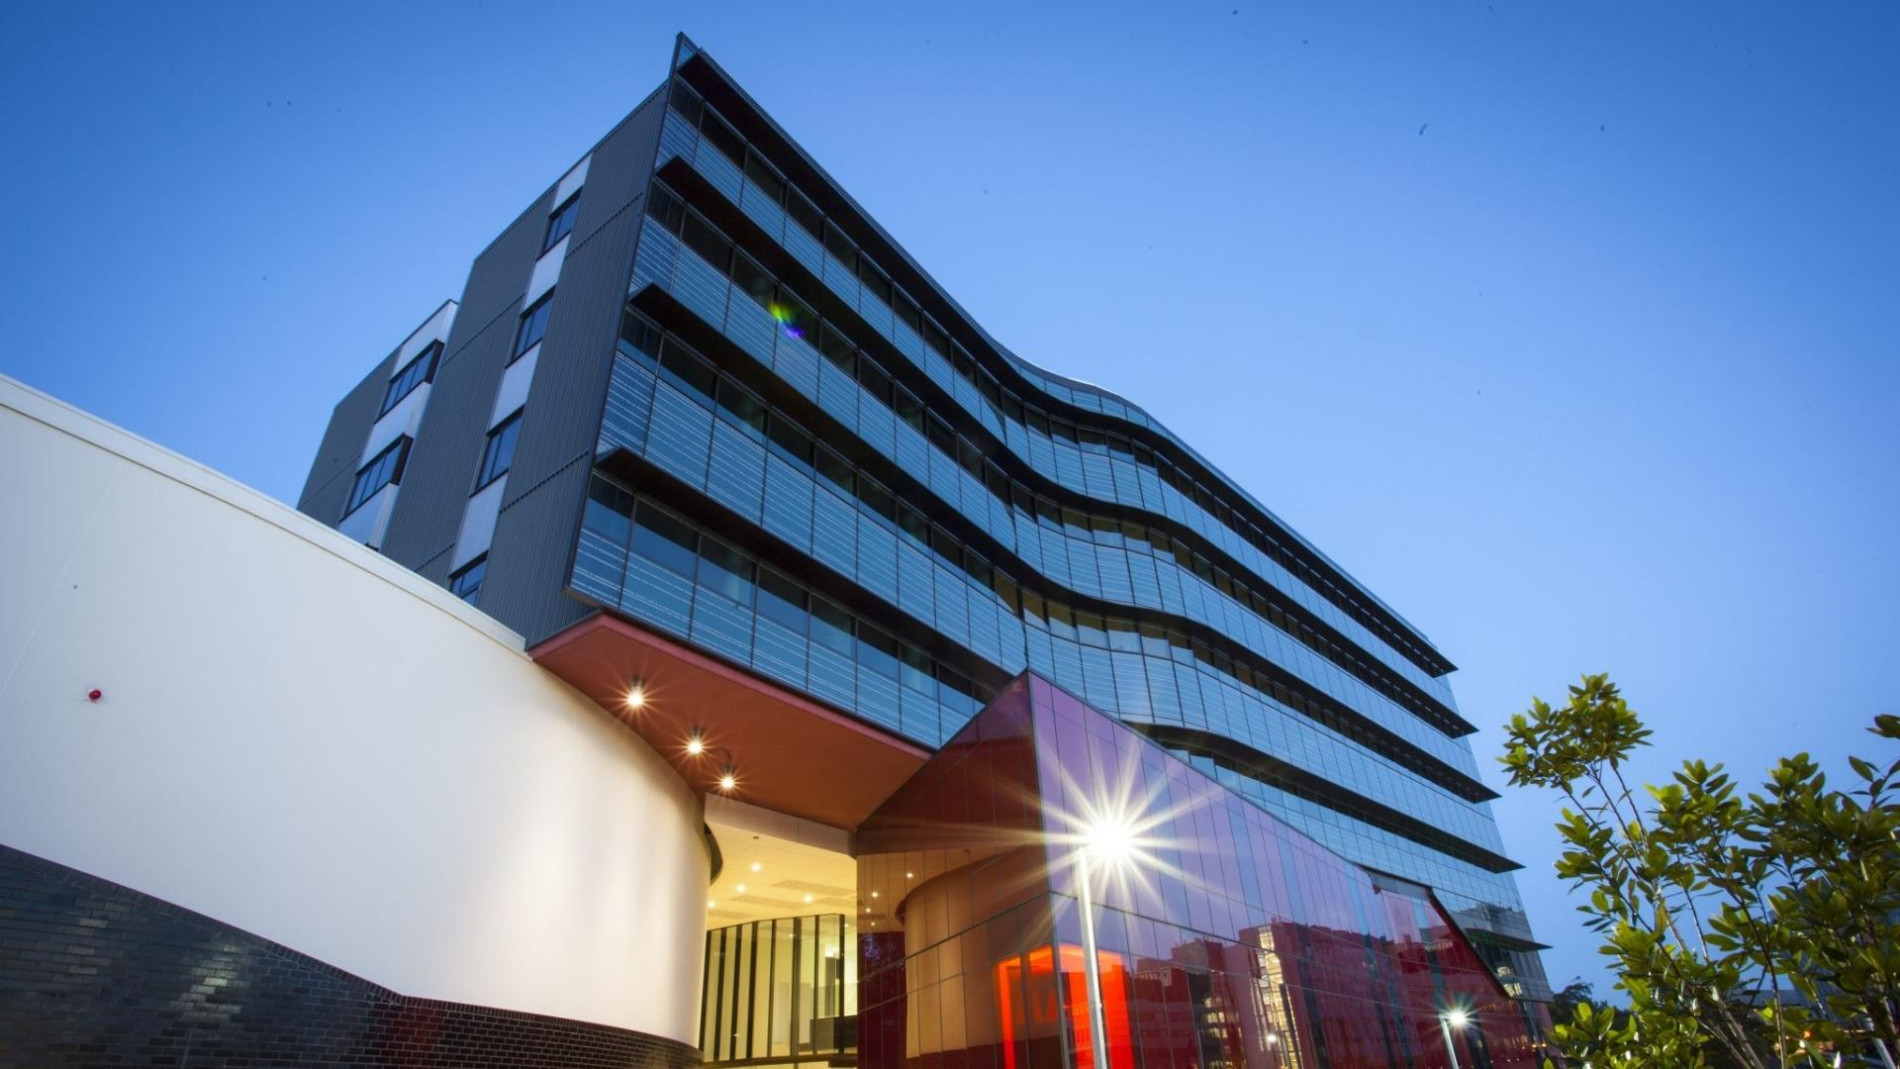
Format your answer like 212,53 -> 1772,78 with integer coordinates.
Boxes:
857,676 -> 1541,1069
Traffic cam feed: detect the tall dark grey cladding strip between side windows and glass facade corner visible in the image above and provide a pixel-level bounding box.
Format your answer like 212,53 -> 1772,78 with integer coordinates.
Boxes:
481,93 -> 665,642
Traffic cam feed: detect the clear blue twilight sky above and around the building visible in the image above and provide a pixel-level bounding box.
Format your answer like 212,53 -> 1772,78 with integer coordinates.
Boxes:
0,0 -> 1900,987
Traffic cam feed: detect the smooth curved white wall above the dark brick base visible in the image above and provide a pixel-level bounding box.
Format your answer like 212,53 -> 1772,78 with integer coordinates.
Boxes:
0,378 -> 707,1046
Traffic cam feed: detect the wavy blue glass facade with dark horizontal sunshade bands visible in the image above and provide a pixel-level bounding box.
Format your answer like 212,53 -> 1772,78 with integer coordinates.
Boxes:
570,55 -> 1549,997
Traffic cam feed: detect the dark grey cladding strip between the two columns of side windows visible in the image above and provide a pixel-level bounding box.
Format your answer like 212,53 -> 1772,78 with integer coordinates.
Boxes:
382,317 -> 515,568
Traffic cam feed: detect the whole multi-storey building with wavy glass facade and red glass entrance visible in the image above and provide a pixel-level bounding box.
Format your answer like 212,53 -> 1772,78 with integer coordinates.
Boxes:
298,29 -> 1550,1069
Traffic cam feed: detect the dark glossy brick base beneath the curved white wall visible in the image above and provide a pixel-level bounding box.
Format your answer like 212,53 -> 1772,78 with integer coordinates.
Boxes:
0,847 -> 699,1069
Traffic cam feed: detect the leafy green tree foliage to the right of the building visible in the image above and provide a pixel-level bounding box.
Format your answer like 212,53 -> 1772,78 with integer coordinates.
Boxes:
1501,676 -> 1900,1069
